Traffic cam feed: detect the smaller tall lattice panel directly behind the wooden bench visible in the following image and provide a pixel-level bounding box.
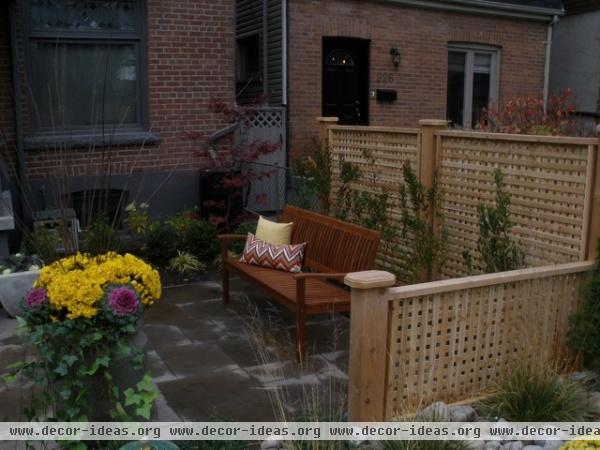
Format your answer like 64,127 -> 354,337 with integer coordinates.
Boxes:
329,126 -> 419,271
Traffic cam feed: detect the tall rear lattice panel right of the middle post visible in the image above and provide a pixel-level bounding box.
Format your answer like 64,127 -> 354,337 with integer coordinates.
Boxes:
438,132 -> 593,277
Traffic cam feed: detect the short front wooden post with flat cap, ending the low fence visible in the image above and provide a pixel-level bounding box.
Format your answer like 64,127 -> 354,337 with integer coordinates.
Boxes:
344,270 -> 396,422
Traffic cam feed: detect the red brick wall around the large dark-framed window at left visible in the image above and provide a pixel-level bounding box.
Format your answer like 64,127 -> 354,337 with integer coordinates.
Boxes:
0,0 -> 234,180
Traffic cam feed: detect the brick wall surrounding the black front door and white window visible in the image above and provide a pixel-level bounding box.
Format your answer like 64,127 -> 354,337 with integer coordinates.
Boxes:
288,0 -> 546,159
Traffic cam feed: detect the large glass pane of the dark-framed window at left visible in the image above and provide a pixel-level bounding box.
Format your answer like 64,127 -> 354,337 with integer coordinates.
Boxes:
31,42 -> 138,129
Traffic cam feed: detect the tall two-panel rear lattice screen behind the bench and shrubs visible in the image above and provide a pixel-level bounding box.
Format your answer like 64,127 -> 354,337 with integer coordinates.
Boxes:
329,126 -> 600,278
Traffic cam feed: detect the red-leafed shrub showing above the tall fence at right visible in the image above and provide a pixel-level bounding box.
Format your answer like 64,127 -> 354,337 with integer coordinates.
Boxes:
479,89 -> 578,136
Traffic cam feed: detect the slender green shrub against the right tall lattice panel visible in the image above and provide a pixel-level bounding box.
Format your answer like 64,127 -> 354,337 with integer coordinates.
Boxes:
463,169 -> 525,273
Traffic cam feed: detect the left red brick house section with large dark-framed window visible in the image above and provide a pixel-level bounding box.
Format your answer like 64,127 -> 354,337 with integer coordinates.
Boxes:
0,0 -> 235,218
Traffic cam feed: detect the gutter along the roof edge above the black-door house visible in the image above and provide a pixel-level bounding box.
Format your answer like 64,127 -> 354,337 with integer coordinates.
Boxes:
378,0 -> 565,22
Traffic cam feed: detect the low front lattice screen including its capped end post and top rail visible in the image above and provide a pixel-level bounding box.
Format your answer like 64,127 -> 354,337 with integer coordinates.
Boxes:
347,262 -> 593,420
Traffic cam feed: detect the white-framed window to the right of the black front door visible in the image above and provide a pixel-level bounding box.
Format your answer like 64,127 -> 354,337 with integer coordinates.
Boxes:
446,45 -> 500,128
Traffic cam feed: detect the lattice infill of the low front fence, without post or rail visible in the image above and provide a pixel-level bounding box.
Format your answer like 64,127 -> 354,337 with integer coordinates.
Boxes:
385,263 -> 589,420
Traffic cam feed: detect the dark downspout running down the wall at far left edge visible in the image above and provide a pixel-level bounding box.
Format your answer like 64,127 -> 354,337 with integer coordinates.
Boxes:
8,1 -> 27,218
